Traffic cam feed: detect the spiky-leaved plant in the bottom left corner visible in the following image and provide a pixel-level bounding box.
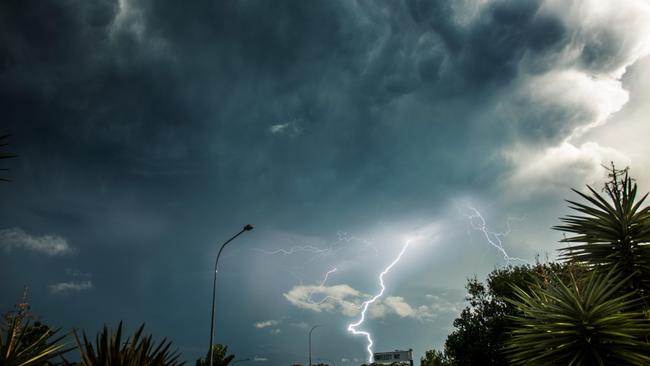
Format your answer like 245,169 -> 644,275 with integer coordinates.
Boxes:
0,317 -> 72,366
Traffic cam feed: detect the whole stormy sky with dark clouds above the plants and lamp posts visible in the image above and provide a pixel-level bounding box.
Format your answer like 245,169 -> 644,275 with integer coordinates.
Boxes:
0,0 -> 650,365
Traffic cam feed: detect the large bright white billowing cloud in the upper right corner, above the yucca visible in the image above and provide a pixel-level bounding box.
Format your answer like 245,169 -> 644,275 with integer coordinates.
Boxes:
498,0 -> 650,196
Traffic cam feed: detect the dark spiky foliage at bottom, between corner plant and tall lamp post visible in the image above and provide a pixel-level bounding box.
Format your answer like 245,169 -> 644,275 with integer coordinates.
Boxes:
75,322 -> 184,366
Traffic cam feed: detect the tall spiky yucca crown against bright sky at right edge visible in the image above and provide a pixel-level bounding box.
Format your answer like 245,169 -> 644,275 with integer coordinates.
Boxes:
554,169 -> 650,294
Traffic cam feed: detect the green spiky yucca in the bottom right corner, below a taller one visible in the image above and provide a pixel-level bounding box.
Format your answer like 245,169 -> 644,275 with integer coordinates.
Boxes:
506,268 -> 650,366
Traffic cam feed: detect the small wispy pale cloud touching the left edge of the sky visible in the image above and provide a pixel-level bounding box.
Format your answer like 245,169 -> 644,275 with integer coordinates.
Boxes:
0,228 -> 73,256
